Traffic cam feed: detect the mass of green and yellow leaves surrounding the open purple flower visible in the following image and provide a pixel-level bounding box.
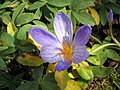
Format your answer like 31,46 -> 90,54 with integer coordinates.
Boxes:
0,0 -> 120,90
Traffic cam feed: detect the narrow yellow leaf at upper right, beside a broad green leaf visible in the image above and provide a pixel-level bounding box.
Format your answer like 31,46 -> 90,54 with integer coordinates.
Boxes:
88,7 -> 100,25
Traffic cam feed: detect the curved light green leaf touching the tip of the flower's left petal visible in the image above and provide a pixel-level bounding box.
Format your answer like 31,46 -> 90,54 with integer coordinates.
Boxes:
17,24 -> 32,40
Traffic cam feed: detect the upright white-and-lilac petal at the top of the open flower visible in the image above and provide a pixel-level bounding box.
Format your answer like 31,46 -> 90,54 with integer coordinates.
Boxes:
54,12 -> 73,43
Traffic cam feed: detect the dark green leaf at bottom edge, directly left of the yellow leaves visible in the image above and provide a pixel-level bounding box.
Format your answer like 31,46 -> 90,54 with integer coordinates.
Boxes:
40,81 -> 60,90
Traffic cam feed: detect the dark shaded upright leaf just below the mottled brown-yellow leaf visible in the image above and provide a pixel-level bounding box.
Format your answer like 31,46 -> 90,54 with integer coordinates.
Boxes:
33,65 -> 44,81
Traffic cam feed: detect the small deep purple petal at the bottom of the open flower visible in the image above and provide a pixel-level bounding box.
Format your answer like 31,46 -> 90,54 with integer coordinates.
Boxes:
55,60 -> 72,72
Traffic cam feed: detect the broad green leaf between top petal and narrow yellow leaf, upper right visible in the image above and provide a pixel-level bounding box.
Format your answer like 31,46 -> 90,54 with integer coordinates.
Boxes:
73,11 -> 95,26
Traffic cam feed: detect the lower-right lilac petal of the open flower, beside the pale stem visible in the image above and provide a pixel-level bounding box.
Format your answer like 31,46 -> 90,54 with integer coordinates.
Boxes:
72,46 -> 89,64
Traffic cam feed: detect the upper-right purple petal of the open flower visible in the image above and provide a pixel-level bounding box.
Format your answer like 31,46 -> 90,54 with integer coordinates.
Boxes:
74,24 -> 92,46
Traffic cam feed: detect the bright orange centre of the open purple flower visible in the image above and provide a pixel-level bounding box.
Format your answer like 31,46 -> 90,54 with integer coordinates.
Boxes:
60,44 -> 74,62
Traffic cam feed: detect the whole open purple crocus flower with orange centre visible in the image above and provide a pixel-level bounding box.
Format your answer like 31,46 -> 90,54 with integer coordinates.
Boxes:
29,12 -> 92,71
